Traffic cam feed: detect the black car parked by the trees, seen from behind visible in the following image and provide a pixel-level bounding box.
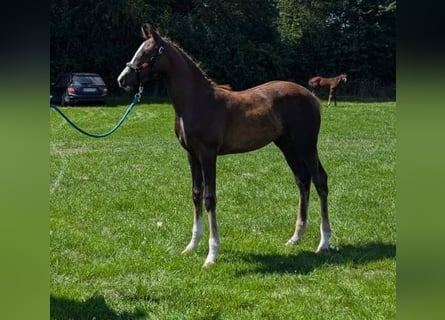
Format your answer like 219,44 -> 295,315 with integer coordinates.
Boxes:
50,72 -> 108,105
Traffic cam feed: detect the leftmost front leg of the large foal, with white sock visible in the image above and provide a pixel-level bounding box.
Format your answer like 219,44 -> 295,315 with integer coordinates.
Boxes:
182,153 -> 203,253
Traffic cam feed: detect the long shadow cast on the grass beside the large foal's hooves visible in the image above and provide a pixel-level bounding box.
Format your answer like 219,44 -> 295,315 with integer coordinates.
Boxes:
238,243 -> 396,276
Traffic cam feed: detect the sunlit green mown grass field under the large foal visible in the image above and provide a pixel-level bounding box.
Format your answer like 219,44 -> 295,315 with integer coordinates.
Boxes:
50,101 -> 396,320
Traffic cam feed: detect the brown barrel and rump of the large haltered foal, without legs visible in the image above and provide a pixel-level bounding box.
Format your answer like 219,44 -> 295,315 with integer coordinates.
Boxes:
215,81 -> 320,154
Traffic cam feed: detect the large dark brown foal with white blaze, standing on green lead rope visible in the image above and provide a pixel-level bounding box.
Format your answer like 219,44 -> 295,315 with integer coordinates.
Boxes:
118,24 -> 331,266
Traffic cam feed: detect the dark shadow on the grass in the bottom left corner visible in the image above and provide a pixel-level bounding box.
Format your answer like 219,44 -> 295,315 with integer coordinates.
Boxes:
50,295 -> 148,320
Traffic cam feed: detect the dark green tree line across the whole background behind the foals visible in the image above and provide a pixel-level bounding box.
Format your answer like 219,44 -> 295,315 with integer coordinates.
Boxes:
50,0 -> 396,98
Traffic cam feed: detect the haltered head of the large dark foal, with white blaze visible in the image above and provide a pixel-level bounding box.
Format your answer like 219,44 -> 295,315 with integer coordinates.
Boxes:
117,23 -> 164,91
